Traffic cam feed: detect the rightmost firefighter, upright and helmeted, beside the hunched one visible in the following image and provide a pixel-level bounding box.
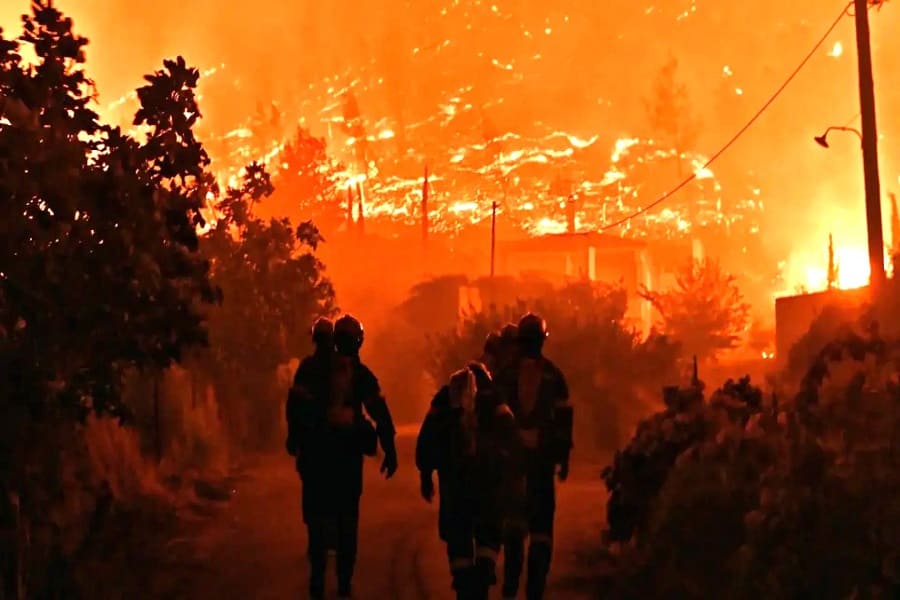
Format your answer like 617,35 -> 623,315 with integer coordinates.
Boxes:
500,313 -> 572,600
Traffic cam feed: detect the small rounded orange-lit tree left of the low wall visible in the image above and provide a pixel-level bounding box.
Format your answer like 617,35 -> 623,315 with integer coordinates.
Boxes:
641,259 -> 750,359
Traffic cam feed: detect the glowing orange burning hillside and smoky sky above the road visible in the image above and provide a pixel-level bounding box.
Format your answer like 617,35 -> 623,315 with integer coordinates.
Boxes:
0,0 -> 900,300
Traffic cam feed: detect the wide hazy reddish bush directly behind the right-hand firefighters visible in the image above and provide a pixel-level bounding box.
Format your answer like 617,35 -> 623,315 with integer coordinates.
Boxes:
426,282 -> 680,449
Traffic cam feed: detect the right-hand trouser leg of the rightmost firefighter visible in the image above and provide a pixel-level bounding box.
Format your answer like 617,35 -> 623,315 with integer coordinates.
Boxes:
526,469 -> 556,600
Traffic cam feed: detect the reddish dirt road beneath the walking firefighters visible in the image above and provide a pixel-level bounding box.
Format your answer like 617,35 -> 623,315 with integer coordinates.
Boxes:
173,428 -> 603,600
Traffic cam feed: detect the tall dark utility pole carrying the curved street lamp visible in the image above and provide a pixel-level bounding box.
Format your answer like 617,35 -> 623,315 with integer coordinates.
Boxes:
853,0 -> 885,294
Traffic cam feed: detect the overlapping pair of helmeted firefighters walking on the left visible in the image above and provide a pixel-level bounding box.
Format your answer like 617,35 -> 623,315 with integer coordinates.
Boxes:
287,315 -> 397,598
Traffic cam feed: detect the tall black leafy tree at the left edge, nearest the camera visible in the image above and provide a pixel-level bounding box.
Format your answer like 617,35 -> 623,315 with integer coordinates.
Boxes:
0,2 -> 216,416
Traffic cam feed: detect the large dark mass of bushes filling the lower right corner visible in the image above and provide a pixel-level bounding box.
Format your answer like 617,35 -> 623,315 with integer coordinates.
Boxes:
605,334 -> 900,598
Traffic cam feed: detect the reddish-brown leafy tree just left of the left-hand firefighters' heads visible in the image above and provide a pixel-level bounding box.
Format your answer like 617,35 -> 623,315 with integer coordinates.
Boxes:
199,163 -> 337,443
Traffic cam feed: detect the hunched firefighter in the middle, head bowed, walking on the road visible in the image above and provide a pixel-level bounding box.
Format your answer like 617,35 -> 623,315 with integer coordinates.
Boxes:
416,362 -> 518,600
